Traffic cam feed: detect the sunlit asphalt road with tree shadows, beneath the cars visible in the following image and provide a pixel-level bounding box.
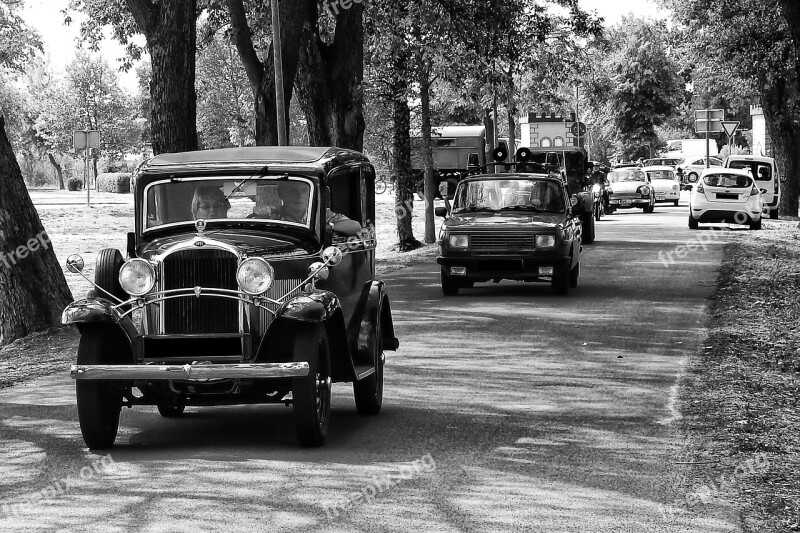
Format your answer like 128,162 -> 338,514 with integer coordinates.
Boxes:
0,197 -> 738,532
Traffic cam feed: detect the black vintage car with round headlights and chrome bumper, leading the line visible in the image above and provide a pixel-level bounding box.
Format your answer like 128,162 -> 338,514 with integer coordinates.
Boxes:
63,147 -> 398,448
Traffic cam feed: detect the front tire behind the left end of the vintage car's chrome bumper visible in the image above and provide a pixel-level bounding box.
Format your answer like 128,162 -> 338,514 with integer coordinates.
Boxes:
75,325 -> 125,450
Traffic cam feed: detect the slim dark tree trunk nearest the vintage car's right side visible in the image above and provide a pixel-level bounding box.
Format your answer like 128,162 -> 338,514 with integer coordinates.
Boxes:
391,51 -> 422,252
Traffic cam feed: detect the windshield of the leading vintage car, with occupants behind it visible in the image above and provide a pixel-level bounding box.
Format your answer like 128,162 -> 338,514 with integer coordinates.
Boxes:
143,176 -> 314,229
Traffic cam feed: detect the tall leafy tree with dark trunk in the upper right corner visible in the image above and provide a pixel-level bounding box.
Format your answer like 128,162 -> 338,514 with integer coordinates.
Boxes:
661,0 -> 800,216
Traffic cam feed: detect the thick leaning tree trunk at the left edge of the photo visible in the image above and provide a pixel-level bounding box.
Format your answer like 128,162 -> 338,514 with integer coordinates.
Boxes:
0,116 -> 72,345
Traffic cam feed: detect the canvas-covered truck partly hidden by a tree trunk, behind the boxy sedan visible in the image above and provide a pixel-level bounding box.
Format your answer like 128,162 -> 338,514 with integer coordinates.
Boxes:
411,126 -> 486,197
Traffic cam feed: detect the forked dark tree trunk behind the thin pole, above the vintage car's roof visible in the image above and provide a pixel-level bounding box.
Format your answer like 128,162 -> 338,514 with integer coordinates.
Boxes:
227,0 -> 309,146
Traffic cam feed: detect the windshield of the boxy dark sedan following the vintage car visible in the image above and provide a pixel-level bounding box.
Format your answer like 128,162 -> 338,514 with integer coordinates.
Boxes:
453,178 -> 566,213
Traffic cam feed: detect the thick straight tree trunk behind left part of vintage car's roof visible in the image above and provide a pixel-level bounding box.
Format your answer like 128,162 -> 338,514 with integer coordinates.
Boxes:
125,0 -> 197,155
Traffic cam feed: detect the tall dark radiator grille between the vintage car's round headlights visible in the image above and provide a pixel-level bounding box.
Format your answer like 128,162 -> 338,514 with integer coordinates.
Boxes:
163,250 -> 239,334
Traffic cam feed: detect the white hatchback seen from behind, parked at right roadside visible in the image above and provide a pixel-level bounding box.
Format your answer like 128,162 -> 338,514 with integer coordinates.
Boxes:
689,167 -> 764,229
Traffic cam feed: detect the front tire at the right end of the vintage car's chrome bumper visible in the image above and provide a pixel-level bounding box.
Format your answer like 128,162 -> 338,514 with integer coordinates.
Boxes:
292,324 -> 331,448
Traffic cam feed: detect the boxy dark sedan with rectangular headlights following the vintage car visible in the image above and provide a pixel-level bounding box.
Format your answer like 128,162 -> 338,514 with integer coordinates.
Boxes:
436,172 -> 592,296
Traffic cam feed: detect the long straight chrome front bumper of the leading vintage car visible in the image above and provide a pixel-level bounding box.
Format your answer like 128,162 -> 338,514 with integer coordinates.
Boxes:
69,363 -> 308,380
